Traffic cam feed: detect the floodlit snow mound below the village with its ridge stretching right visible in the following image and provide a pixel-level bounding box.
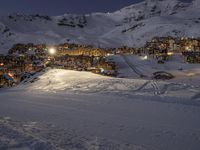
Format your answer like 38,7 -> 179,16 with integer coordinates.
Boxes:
15,69 -> 199,103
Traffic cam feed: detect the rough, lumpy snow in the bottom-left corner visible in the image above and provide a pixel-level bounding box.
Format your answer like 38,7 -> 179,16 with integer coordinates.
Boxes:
0,117 -> 140,150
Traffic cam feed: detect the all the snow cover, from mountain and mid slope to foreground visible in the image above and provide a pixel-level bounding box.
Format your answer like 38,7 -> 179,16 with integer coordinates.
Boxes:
0,0 -> 200,150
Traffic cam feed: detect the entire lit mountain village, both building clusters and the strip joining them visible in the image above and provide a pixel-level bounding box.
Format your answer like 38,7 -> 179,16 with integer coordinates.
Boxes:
0,37 -> 200,88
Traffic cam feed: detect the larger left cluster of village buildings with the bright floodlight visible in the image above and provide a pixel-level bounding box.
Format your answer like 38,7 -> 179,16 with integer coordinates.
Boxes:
0,43 -> 116,87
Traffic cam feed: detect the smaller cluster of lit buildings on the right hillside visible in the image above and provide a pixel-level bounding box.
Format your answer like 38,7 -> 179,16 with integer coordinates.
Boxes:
142,37 -> 200,63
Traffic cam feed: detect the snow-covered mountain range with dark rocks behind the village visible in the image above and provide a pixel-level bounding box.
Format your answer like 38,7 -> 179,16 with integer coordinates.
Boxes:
0,0 -> 200,52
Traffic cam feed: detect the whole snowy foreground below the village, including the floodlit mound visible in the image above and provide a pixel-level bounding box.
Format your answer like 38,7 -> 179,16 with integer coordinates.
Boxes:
0,55 -> 200,150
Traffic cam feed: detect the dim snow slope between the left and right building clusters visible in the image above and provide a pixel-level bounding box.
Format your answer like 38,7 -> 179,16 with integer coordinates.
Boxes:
112,54 -> 200,86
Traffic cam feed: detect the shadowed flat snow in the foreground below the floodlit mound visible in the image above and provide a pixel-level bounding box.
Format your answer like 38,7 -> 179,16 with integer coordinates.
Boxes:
0,82 -> 200,150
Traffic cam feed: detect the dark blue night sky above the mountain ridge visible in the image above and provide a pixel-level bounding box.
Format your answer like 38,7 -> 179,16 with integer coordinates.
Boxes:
0,0 -> 191,15
